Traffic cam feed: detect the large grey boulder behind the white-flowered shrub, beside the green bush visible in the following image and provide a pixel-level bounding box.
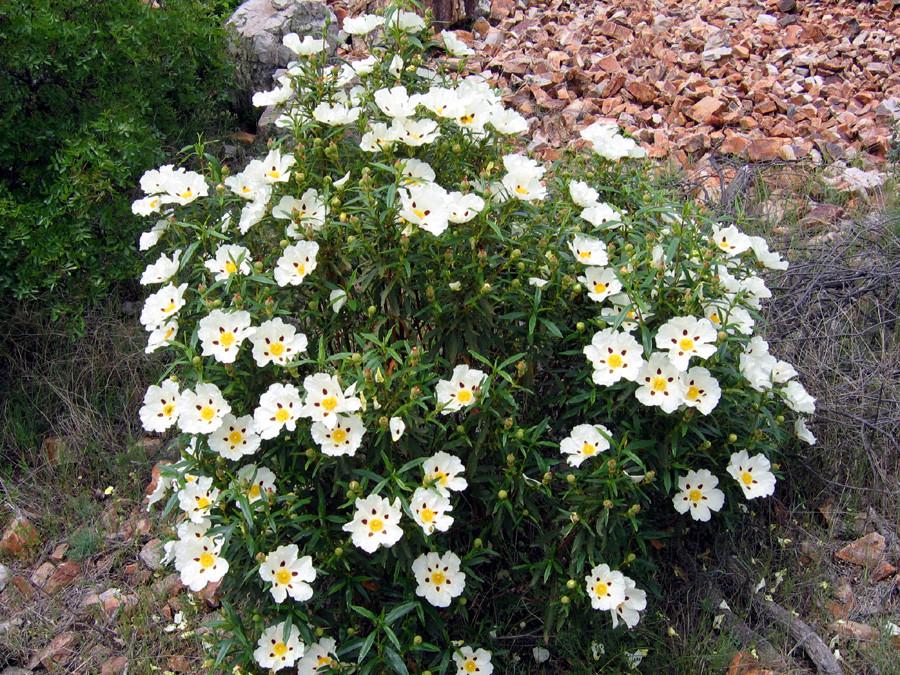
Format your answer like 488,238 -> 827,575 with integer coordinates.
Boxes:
225,0 -> 338,108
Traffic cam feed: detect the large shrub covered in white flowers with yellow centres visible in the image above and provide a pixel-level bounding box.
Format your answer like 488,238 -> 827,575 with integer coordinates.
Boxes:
134,3 -> 813,675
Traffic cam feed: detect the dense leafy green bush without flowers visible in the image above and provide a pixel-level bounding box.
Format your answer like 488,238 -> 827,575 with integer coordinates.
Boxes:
0,0 -> 231,324
